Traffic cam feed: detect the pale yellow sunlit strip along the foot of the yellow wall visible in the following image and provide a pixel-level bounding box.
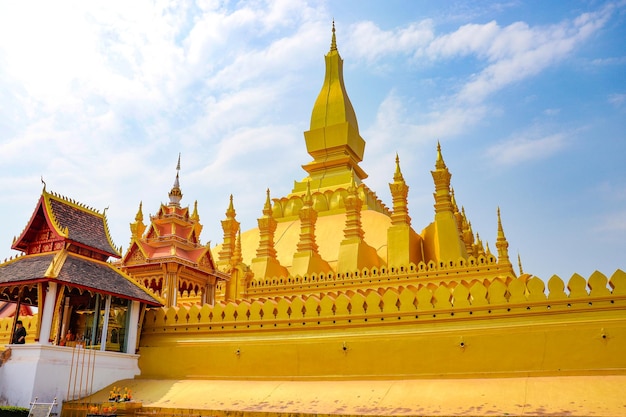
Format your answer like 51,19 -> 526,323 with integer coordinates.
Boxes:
80,375 -> 626,417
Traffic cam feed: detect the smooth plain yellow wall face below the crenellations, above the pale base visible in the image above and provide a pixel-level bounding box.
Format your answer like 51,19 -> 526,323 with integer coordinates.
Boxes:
140,319 -> 626,379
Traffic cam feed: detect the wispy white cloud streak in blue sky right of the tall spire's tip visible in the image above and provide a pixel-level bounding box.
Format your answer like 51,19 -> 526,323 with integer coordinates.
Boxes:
342,4 -> 614,105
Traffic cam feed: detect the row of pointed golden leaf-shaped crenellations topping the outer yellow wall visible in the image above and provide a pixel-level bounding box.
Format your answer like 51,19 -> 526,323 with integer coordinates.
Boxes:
144,270 -> 626,334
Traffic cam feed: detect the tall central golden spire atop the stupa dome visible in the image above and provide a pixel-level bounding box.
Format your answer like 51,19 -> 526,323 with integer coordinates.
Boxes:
293,22 -> 367,194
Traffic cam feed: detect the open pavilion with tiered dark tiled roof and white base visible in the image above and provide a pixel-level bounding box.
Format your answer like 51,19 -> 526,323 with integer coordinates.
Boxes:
0,184 -> 162,405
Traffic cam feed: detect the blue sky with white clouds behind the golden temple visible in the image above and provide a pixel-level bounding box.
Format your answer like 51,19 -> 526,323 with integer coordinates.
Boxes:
0,0 -> 626,280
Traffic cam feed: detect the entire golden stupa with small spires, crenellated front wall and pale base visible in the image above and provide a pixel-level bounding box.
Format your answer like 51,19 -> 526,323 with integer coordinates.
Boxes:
125,27 -> 626,415
